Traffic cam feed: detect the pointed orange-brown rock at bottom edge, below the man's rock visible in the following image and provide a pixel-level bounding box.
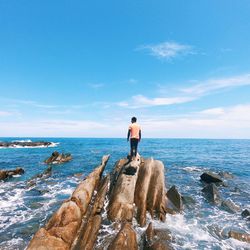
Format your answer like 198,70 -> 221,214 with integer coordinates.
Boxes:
108,222 -> 138,250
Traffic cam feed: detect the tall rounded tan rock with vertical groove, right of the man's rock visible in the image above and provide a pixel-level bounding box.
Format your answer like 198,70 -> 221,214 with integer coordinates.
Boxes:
135,158 -> 166,226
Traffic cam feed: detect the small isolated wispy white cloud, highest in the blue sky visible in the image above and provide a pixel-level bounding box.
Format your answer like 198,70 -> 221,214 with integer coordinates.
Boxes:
138,42 -> 195,59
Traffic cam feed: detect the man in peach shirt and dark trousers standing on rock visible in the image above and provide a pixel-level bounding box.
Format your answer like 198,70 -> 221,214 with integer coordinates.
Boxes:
127,117 -> 141,160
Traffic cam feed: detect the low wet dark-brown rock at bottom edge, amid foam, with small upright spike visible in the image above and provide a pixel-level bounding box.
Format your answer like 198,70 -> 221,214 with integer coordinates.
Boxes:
143,222 -> 173,250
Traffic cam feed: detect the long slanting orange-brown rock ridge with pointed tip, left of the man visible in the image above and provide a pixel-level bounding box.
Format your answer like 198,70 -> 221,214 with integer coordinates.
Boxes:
27,156 -> 109,250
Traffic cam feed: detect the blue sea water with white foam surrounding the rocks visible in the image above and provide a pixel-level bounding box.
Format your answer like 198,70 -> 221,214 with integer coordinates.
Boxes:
0,138 -> 250,249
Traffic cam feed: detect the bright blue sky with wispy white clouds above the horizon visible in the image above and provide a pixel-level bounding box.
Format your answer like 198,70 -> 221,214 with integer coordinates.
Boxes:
0,0 -> 250,138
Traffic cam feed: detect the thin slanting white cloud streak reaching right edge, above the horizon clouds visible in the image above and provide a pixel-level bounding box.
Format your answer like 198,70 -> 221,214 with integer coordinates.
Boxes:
181,74 -> 250,95
